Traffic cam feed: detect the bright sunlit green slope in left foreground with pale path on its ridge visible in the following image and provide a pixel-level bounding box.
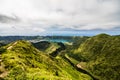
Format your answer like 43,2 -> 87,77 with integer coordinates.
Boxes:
0,41 -> 92,80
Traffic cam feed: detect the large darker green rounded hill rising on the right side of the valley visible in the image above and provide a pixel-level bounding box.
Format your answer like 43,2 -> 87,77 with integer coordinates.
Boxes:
74,34 -> 120,80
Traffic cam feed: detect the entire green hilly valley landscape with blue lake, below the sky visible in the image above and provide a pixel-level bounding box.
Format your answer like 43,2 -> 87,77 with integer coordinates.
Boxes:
0,34 -> 120,80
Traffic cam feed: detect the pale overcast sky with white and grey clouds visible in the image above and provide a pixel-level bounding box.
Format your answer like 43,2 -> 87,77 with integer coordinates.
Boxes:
0,0 -> 120,35
